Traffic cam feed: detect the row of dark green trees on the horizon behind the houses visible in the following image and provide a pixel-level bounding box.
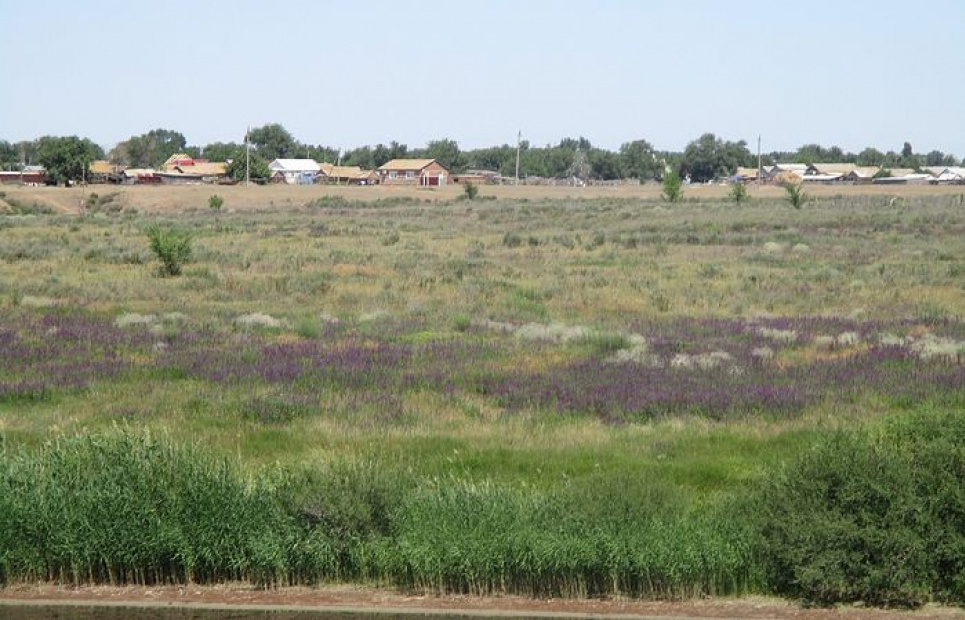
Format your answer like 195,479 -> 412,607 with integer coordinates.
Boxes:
0,123 -> 965,183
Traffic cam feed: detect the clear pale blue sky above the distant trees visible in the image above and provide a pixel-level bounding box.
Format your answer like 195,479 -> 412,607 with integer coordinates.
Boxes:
0,0 -> 965,157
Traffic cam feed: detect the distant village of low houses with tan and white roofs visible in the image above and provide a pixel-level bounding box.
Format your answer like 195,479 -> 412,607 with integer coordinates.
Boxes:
0,153 -> 965,188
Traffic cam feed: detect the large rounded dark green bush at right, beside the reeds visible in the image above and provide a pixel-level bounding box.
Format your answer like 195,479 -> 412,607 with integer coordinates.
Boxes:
753,412 -> 965,607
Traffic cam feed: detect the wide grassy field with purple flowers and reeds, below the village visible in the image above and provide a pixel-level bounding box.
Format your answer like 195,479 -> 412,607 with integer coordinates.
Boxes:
0,187 -> 965,605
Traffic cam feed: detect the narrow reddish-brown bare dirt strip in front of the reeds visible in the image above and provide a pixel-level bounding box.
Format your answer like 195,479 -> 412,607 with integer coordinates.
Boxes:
0,584 -> 965,620
